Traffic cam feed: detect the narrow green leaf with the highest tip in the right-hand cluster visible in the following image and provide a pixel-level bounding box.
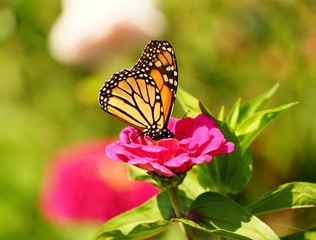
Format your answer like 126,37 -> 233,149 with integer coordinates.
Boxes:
239,83 -> 280,121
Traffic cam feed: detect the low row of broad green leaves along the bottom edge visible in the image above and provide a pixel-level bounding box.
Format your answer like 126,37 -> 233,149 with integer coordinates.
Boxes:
95,183 -> 316,240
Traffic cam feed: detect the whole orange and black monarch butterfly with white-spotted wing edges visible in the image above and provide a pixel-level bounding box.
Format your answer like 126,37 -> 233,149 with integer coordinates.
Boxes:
99,40 -> 178,140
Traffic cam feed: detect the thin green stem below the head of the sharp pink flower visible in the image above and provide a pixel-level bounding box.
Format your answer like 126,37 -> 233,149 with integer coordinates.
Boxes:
166,186 -> 193,240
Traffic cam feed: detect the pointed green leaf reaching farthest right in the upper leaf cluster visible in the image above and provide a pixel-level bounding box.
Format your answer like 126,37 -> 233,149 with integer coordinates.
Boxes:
235,103 -> 297,153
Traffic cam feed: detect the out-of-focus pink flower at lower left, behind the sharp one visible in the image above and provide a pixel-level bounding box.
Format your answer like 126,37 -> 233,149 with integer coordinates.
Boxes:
40,140 -> 158,223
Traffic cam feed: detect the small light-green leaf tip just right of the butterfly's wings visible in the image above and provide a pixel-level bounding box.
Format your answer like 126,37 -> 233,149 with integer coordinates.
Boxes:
177,87 -> 201,117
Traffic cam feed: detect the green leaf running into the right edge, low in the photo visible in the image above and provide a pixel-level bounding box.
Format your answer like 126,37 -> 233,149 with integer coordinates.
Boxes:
246,182 -> 316,214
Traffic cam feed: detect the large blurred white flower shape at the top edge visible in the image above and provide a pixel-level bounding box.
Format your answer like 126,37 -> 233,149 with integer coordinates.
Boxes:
49,0 -> 165,64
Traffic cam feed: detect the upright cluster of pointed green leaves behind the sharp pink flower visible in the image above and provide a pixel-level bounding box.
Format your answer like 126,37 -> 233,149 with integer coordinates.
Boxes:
178,84 -> 296,194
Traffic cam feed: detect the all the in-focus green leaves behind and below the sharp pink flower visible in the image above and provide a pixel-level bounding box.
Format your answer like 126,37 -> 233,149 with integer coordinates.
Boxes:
95,85 -> 316,240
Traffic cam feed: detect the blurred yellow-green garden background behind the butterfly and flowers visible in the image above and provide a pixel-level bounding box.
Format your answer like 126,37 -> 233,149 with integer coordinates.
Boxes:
0,0 -> 316,240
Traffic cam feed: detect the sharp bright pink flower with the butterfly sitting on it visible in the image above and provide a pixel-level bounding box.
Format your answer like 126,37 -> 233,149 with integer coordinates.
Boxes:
106,114 -> 234,177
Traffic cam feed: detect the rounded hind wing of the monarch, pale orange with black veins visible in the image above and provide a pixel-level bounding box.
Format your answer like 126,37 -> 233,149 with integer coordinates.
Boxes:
99,70 -> 163,132
